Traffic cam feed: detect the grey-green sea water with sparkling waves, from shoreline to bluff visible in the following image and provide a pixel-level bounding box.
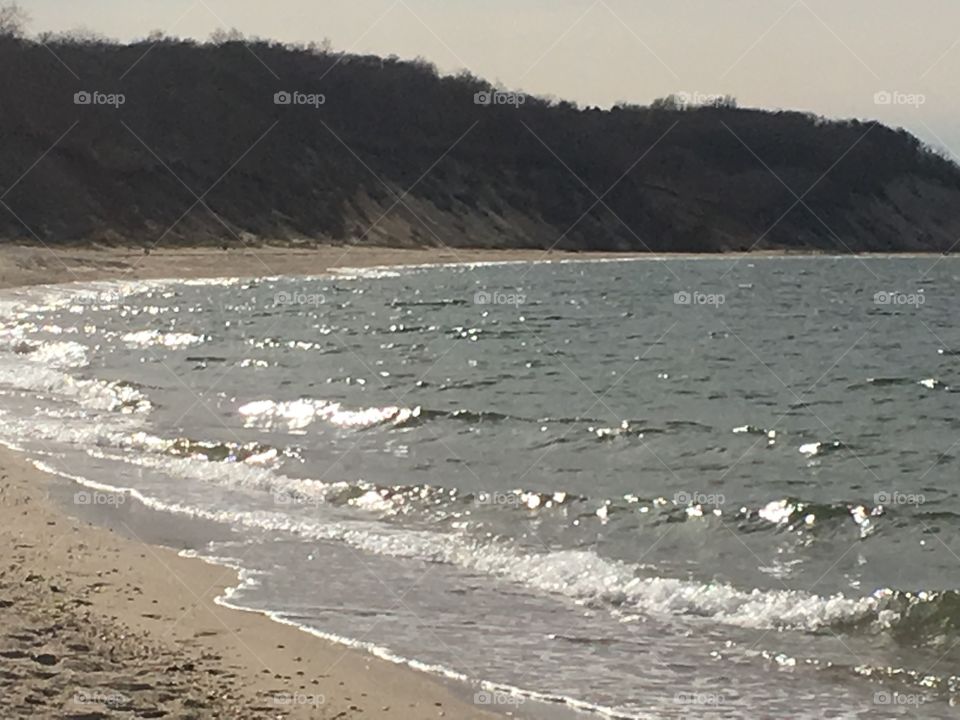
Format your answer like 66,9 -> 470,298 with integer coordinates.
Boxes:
0,257 -> 960,718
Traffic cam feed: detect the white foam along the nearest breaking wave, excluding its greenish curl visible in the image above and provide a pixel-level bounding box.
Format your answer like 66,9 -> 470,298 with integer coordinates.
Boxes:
56,472 -> 881,631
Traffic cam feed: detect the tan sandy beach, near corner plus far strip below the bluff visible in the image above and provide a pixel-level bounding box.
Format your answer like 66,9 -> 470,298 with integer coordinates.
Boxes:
0,247 -> 600,720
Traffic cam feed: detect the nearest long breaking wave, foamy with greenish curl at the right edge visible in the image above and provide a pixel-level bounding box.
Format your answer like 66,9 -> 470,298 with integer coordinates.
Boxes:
144,500 -> 960,645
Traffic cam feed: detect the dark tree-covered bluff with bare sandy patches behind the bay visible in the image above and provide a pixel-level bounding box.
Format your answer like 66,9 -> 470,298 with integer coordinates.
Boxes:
0,38 -> 960,252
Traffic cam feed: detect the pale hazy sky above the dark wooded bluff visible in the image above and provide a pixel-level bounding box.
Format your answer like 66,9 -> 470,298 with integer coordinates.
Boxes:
20,0 -> 960,159
